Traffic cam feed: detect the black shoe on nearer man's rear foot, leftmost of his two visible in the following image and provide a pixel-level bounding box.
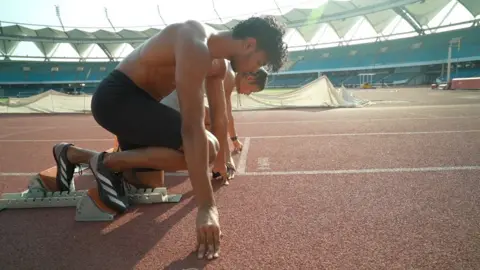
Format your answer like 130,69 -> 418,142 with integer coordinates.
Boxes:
53,143 -> 75,191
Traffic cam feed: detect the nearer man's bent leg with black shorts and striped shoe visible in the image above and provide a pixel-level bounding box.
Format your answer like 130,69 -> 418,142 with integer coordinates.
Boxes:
90,71 -> 219,212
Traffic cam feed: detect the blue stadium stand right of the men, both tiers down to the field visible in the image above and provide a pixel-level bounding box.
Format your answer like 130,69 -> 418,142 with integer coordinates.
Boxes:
270,26 -> 480,88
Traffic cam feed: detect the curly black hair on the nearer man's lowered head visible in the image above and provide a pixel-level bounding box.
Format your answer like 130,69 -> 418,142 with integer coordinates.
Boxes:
232,16 -> 288,72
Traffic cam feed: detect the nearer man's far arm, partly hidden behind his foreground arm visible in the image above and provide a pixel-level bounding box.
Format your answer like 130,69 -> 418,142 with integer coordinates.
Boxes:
206,60 -> 228,175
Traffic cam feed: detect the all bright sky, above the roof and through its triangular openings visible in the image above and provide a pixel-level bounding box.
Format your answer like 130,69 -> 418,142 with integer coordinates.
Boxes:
0,0 -> 473,59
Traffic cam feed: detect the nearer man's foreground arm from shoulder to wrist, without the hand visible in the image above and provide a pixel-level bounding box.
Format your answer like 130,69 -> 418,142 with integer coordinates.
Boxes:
174,22 -> 215,207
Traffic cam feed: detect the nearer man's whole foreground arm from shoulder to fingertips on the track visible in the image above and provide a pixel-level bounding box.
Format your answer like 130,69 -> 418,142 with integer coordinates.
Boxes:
173,22 -> 221,259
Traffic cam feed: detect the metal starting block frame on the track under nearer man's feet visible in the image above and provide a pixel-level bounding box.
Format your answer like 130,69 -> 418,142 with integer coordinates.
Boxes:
0,187 -> 182,221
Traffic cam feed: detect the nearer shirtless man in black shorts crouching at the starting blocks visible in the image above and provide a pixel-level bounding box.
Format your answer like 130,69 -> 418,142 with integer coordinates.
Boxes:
53,17 -> 287,259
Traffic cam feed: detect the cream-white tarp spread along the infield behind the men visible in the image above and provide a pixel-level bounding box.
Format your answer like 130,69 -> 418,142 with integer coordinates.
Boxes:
0,76 -> 370,113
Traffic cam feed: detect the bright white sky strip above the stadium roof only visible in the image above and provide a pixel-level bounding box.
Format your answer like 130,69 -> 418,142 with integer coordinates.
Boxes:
0,0 -> 326,30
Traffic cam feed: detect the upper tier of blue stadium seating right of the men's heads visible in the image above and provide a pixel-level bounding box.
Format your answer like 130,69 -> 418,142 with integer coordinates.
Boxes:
287,27 -> 480,71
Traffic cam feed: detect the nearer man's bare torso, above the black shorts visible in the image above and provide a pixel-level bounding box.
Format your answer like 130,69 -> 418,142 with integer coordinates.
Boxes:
117,21 -> 225,101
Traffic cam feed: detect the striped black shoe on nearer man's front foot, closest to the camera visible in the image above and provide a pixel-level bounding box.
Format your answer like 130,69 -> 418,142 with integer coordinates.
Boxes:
90,152 -> 128,213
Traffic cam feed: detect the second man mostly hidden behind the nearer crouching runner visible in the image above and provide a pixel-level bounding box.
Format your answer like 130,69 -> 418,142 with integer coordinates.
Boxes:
161,65 -> 268,181
